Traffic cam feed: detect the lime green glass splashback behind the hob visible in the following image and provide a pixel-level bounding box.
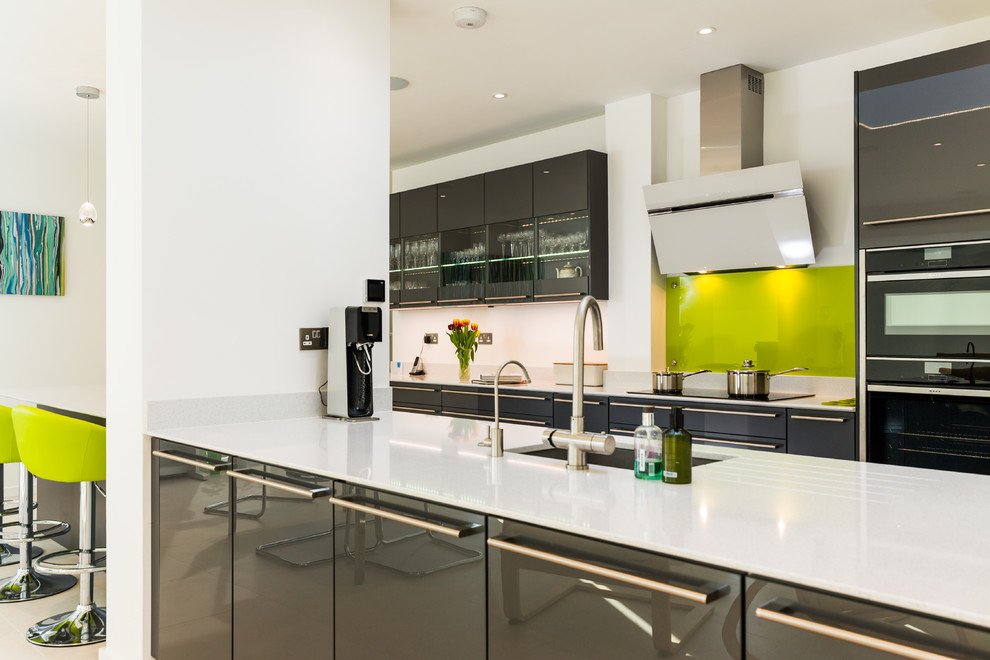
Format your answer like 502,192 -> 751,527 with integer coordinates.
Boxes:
666,266 -> 856,378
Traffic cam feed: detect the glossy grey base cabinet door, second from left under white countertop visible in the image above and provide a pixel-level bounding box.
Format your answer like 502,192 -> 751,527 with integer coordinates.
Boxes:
229,459 -> 333,660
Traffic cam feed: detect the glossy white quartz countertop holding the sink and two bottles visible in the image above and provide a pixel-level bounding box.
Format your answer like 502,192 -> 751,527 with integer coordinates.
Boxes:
153,412 -> 990,627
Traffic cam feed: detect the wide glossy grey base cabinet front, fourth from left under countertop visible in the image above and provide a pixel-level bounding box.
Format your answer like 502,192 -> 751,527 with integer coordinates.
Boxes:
488,512 -> 742,660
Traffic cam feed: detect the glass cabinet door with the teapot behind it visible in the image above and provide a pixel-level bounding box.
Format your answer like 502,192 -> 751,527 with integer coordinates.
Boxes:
535,211 -> 592,301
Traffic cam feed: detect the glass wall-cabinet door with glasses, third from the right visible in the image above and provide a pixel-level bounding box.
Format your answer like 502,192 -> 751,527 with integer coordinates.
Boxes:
440,225 -> 487,305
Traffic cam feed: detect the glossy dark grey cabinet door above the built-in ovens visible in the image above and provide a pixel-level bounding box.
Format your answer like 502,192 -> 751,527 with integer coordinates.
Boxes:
856,41 -> 990,248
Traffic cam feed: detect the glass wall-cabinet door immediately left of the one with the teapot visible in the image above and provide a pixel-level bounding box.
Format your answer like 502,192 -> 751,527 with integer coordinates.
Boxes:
485,218 -> 536,303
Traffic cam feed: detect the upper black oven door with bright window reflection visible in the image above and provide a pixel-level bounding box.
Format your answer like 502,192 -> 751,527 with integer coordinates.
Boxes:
866,269 -> 990,358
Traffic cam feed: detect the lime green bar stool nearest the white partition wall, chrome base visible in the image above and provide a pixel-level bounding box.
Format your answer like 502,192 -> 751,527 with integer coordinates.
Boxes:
12,406 -> 107,646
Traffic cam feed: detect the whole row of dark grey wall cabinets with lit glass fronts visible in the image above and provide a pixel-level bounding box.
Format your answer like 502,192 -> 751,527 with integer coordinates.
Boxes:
390,151 -> 608,309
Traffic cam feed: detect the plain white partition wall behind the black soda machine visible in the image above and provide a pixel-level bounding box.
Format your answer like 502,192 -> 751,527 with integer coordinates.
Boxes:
101,0 -> 389,660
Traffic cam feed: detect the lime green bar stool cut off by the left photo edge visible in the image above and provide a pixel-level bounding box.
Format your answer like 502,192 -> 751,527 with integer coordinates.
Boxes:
0,406 -> 76,603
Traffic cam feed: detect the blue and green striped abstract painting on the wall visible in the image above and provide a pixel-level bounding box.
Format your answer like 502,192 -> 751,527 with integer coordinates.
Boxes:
0,211 -> 65,296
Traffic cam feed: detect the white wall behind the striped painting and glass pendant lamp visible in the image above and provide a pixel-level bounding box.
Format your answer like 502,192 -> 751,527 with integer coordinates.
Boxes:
0,0 -> 106,392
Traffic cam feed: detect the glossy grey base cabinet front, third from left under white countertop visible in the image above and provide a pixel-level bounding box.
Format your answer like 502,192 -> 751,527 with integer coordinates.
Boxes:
334,484 -> 485,660
